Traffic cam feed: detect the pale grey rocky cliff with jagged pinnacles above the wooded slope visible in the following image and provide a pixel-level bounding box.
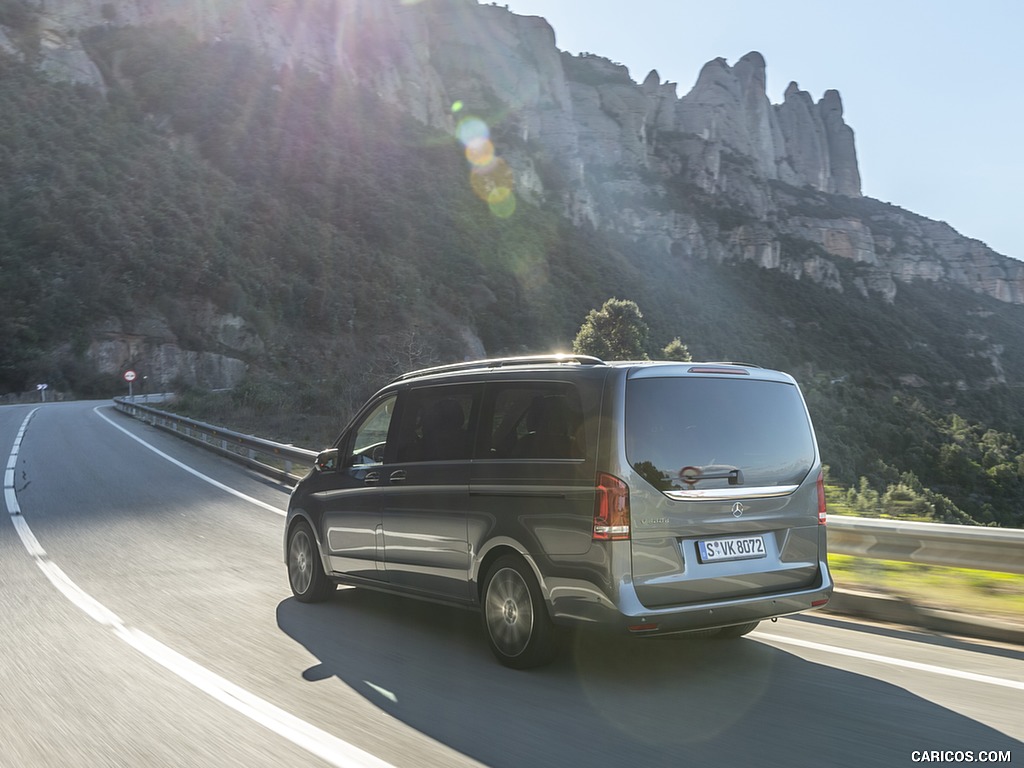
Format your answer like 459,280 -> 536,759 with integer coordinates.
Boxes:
0,0 -> 1024,319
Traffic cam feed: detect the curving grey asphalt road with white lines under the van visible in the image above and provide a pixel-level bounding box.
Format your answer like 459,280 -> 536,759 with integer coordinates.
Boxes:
0,402 -> 1024,768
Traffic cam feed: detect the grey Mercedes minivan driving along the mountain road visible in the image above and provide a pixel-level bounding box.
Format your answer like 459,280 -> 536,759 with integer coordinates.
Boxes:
285,355 -> 833,669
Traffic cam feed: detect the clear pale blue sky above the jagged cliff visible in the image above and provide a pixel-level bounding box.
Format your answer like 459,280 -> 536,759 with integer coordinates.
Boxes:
498,0 -> 1024,260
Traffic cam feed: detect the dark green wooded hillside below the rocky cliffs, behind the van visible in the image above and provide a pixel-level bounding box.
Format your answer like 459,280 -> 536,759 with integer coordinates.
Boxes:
0,28 -> 1024,526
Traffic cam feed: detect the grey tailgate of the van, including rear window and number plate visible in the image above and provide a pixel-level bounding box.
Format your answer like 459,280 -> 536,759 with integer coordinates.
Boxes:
625,366 -> 824,607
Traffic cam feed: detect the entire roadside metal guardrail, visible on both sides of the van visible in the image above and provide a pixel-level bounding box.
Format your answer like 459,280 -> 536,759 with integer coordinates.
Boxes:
114,397 -> 1024,573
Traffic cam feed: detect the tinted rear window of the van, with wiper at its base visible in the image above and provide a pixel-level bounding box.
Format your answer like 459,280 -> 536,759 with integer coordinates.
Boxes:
626,377 -> 815,490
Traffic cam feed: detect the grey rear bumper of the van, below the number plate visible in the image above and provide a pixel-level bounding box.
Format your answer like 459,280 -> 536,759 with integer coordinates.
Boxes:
551,562 -> 834,635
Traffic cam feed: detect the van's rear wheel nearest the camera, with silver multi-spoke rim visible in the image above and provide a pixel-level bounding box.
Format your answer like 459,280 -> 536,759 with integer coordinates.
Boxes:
482,555 -> 558,670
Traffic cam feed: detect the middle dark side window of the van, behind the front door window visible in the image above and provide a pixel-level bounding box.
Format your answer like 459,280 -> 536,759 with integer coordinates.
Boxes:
395,384 -> 482,463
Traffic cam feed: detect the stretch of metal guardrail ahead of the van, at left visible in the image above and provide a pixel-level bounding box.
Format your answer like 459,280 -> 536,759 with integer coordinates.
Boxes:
114,397 -> 316,483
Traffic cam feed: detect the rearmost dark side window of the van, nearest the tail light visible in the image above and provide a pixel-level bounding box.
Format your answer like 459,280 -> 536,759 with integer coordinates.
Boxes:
488,382 -> 587,459
